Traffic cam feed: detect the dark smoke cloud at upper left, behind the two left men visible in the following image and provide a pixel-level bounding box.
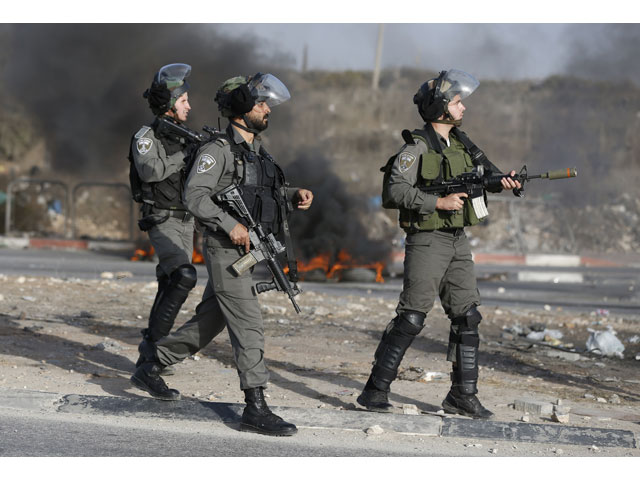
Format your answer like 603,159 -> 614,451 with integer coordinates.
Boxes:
0,24 -> 290,178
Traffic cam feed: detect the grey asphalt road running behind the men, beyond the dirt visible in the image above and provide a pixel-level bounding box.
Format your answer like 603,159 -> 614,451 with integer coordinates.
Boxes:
0,249 -> 640,313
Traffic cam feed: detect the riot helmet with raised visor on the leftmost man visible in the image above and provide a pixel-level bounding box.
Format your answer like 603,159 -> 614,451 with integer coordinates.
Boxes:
142,63 -> 191,115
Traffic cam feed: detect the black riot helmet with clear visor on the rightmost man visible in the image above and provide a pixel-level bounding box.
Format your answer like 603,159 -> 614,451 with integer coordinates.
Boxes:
413,69 -> 480,124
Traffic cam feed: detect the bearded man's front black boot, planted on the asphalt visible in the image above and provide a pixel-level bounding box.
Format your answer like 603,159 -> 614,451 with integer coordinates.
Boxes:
240,387 -> 298,437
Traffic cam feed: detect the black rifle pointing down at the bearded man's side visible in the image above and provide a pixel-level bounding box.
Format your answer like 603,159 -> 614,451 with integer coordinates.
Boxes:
215,185 -> 300,313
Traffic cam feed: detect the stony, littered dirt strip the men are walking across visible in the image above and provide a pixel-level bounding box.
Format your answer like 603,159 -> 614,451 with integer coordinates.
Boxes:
0,272 -> 640,455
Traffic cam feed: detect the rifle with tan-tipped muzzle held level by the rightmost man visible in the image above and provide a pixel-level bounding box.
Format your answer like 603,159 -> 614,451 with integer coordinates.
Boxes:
418,165 -> 578,219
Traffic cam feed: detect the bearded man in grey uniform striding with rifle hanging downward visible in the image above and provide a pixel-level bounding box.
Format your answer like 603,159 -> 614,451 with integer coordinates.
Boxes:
134,73 -> 313,435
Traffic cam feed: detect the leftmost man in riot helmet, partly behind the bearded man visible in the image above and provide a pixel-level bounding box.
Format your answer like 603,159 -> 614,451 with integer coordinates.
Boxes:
129,63 -> 196,373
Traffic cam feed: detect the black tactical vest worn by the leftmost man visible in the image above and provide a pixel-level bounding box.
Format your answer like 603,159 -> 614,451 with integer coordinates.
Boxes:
128,122 -> 186,211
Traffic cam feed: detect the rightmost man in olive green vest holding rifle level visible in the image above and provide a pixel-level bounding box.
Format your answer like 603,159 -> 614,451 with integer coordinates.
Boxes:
357,70 -> 521,418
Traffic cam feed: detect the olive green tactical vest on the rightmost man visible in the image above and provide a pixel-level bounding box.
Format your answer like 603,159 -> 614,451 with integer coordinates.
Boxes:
400,130 -> 480,230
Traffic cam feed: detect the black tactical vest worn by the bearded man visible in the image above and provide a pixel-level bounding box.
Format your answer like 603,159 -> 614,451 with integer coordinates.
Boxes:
211,133 -> 291,235
